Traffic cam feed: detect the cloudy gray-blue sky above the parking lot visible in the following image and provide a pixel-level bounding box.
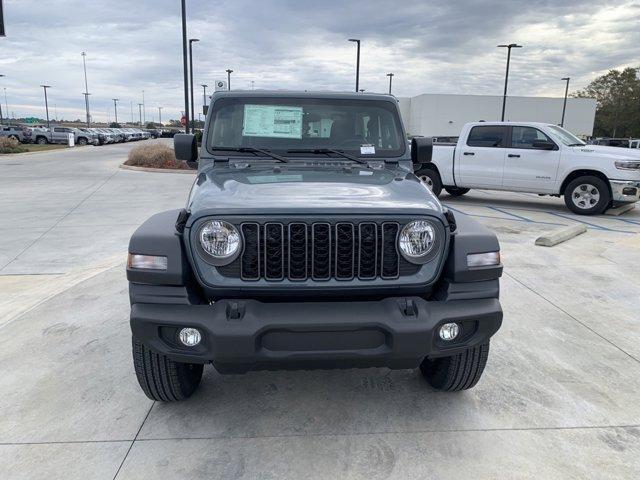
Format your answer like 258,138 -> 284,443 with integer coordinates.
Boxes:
0,0 -> 640,121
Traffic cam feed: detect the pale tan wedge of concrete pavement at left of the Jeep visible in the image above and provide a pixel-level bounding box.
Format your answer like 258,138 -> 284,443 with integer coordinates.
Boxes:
0,253 -> 126,329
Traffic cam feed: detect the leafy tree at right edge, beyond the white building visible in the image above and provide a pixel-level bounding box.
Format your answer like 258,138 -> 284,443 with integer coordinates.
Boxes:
575,68 -> 640,138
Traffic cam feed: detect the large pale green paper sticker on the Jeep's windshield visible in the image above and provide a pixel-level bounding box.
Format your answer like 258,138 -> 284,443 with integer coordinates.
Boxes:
242,105 -> 302,139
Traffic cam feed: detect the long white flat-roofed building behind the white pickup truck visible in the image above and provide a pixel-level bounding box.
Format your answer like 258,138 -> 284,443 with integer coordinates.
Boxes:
398,94 -> 596,137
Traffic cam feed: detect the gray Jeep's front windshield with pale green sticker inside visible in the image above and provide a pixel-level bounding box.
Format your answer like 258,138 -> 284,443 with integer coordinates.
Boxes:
208,97 -> 406,158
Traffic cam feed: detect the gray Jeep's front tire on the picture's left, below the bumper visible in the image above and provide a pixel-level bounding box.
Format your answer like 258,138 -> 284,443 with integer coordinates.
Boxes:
132,338 -> 203,402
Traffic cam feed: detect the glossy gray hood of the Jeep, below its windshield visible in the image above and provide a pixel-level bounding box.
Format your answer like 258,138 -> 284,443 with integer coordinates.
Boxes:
188,166 -> 442,217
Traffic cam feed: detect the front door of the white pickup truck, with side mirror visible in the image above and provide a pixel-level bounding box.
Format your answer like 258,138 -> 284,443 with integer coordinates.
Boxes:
503,126 -> 560,193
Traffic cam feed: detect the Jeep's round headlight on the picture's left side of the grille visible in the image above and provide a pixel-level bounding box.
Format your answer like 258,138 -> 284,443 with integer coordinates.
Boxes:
196,219 -> 242,266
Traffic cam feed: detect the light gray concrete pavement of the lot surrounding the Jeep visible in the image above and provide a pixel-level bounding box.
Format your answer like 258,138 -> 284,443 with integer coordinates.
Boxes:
0,144 -> 640,480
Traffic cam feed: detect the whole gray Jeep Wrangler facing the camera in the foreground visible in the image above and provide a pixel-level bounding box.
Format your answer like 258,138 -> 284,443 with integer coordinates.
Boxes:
127,91 -> 502,401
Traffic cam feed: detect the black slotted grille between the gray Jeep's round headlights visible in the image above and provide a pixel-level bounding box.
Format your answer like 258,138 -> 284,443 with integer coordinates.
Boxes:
225,221 -> 419,281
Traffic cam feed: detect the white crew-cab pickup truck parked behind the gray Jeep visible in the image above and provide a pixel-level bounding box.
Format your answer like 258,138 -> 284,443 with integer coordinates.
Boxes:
414,122 -> 640,215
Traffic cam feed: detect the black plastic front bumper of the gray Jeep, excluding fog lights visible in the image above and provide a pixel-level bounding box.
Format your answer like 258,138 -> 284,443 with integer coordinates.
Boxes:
131,297 -> 502,373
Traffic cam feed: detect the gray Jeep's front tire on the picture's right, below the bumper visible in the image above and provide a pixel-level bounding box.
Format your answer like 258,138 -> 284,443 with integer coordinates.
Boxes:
420,342 -> 489,392
